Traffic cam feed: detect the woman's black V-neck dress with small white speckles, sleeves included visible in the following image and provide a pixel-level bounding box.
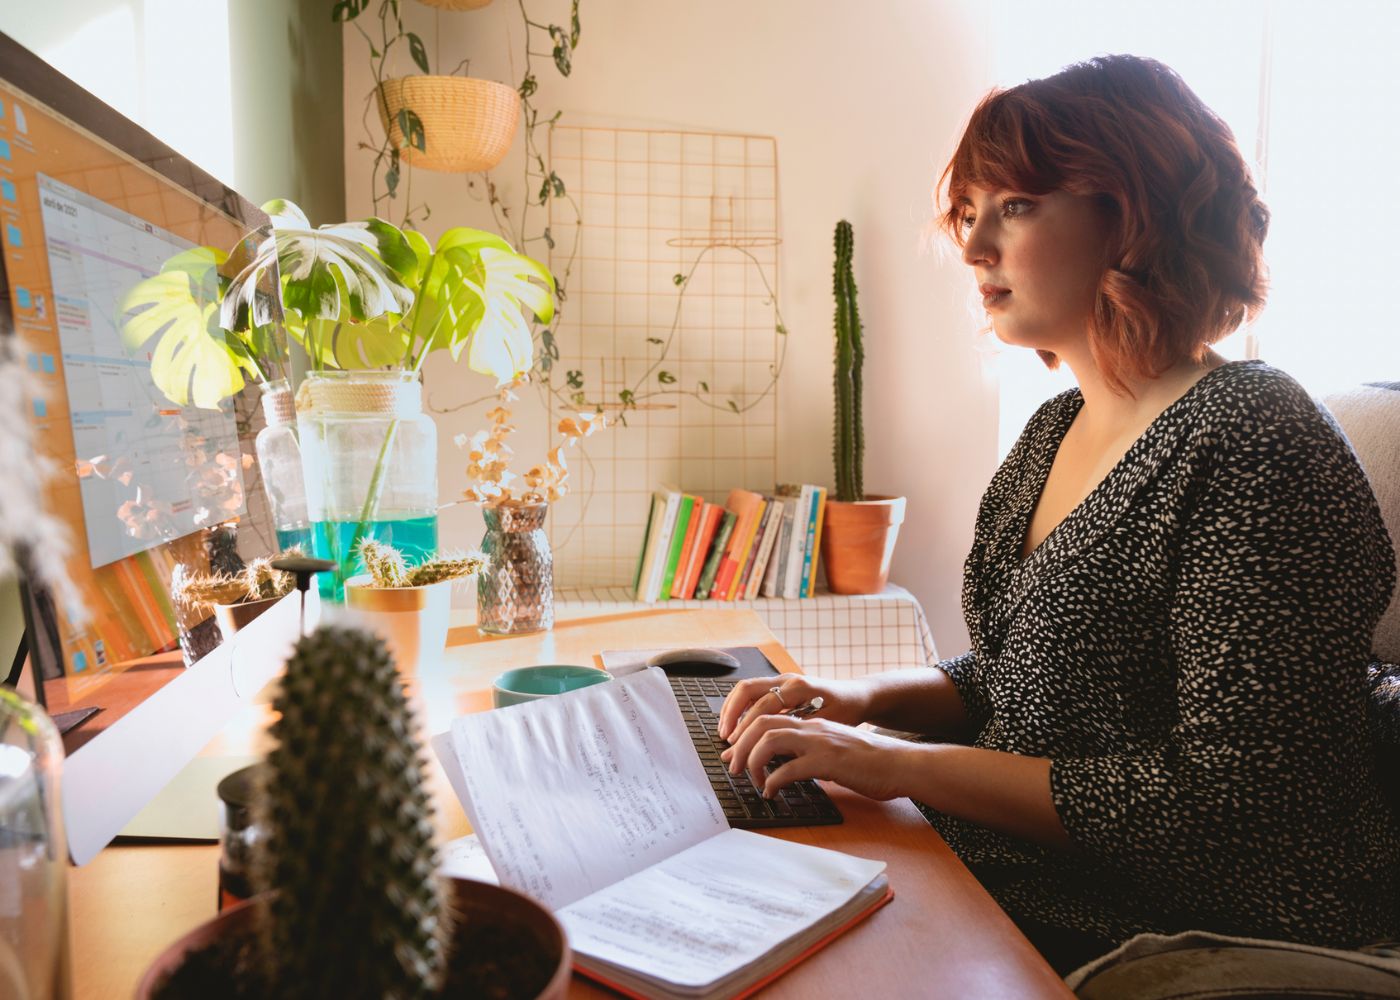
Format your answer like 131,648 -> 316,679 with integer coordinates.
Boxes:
925,361 -> 1400,947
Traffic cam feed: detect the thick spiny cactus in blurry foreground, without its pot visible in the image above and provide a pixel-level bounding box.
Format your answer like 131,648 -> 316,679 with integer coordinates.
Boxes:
256,626 -> 449,1000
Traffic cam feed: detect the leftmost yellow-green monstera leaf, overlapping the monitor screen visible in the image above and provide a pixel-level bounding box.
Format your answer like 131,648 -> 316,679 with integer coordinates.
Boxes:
119,246 -> 258,409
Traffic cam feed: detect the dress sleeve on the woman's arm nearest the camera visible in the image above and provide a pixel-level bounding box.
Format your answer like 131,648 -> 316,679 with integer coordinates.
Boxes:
1050,398 -> 1394,915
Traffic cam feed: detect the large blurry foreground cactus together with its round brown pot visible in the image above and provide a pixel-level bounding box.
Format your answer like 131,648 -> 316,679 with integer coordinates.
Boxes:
139,626 -> 570,1000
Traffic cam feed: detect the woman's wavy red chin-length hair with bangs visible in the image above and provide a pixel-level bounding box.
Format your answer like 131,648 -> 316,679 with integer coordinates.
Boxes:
938,56 -> 1268,391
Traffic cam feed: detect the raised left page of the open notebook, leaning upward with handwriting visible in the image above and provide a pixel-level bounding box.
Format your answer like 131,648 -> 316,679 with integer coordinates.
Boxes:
452,668 -> 729,909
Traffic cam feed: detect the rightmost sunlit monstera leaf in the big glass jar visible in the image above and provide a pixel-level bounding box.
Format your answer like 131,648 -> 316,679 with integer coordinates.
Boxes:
409,227 -> 554,384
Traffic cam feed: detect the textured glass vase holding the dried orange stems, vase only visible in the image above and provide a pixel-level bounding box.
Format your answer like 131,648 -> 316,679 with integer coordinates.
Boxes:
476,503 -> 554,636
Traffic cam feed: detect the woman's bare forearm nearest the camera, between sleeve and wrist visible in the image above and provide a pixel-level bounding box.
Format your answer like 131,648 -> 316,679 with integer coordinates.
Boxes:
895,744 -> 1071,849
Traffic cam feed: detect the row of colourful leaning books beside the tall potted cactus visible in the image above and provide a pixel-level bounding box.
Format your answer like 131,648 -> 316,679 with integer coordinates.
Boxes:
631,485 -> 826,602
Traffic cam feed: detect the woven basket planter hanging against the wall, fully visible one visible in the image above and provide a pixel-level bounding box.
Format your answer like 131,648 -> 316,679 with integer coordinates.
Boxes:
375,76 -> 521,174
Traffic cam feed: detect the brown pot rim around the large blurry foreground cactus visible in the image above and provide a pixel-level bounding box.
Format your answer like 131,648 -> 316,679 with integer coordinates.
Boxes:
136,878 -> 573,1000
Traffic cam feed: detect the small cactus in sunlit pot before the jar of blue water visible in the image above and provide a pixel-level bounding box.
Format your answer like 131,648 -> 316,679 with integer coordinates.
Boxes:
346,538 -> 483,671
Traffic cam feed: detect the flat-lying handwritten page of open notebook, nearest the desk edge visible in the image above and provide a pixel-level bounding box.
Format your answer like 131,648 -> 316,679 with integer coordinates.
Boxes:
557,831 -> 885,987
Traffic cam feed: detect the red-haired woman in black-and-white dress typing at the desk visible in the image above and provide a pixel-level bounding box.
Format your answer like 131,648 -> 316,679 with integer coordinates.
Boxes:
720,56 -> 1400,972
